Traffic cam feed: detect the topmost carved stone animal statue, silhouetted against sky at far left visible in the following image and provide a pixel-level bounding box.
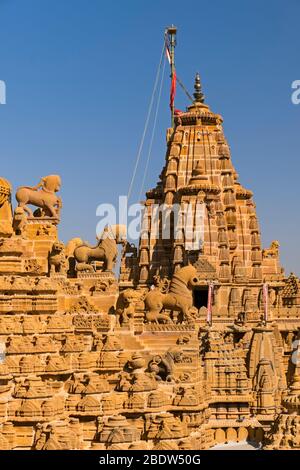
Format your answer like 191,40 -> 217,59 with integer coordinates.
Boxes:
16,175 -> 62,219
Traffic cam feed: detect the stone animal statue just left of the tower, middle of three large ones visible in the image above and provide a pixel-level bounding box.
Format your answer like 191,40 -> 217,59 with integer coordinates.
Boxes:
74,225 -> 126,272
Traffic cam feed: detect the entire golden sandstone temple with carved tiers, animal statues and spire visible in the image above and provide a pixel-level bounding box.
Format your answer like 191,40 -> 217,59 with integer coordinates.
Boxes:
0,76 -> 300,450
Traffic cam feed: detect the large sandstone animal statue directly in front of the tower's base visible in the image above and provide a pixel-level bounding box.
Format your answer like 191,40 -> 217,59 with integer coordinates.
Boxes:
145,265 -> 199,323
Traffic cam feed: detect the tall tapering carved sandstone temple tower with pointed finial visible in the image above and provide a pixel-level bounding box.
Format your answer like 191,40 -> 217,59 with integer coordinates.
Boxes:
139,74 -> 282,319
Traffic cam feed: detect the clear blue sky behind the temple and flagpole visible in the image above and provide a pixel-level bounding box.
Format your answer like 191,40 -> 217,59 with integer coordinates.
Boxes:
0,0 -> 300,274
